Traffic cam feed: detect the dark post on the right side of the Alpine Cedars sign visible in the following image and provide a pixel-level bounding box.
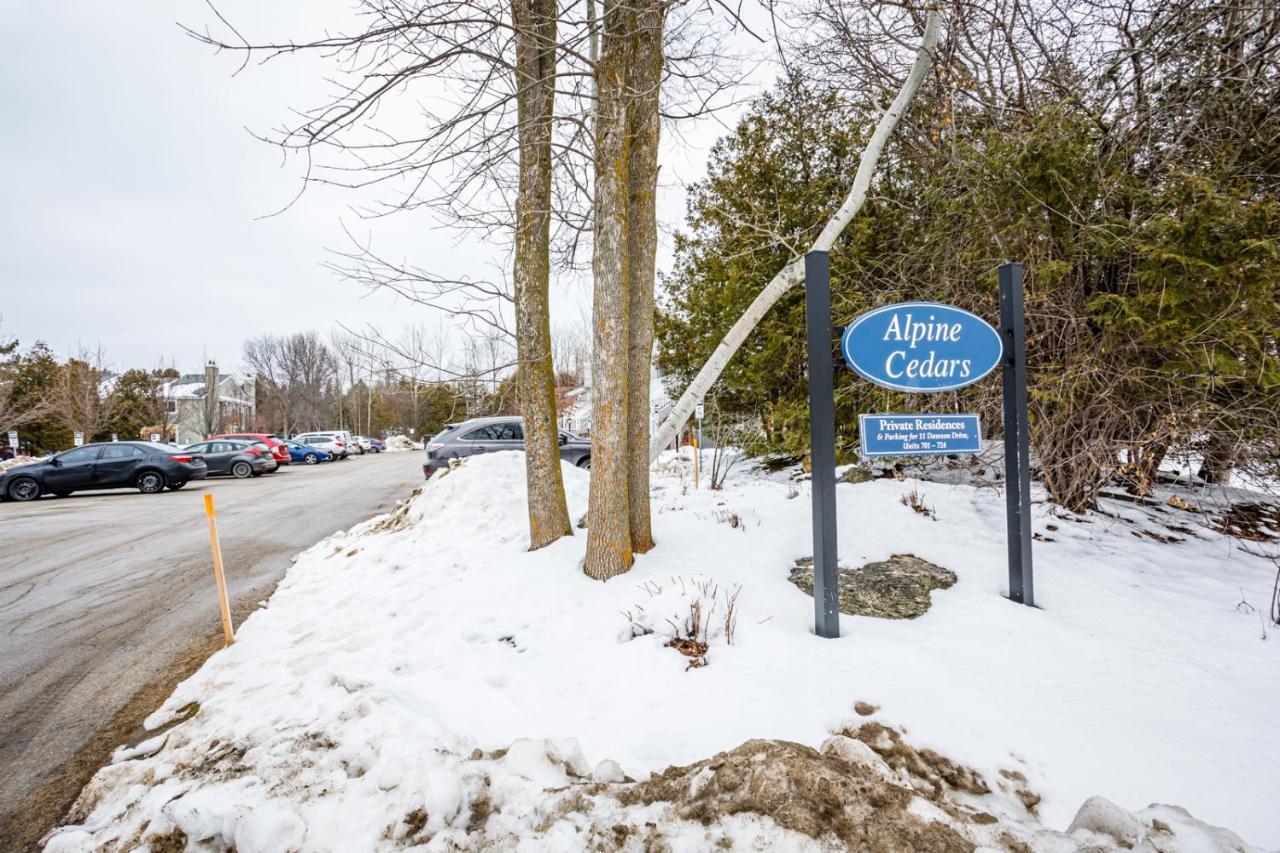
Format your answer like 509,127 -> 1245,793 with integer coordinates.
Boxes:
1000,264 -> 1036,607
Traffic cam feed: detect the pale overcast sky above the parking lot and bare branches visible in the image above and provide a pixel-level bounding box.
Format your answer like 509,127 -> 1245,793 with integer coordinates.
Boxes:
0,0 -> 768,371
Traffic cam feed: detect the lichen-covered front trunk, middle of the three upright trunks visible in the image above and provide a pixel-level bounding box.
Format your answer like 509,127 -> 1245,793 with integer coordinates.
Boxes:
582,0 -> 634,580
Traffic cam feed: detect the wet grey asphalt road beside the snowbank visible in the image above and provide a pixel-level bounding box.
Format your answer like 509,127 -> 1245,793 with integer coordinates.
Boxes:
0,452 -> 422,852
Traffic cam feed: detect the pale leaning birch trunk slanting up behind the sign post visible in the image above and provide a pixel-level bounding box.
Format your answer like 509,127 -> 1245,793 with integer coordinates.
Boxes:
649,9 -> 941,461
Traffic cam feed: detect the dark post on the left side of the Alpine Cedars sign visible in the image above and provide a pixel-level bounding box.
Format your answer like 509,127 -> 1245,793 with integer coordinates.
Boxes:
804,252 -> 840,638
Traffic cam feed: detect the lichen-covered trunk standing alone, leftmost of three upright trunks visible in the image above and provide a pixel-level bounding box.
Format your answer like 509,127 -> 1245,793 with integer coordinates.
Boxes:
511,0 -> 573,549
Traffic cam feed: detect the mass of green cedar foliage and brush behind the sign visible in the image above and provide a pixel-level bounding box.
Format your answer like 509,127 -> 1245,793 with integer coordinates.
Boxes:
658,49 -> 1280,507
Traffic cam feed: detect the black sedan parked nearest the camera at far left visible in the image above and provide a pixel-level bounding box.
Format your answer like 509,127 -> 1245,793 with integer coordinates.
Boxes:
0,442 -> 209,501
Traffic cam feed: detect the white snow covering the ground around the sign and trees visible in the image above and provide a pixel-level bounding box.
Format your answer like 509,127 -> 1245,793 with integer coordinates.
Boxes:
47,453 -> 1280,853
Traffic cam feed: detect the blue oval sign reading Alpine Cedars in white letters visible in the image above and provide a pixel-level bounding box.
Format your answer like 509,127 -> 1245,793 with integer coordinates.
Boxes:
840,302 -> 1004,392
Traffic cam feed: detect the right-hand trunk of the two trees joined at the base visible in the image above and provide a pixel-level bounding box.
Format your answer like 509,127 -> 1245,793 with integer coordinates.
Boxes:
627,0 -> 664,553
